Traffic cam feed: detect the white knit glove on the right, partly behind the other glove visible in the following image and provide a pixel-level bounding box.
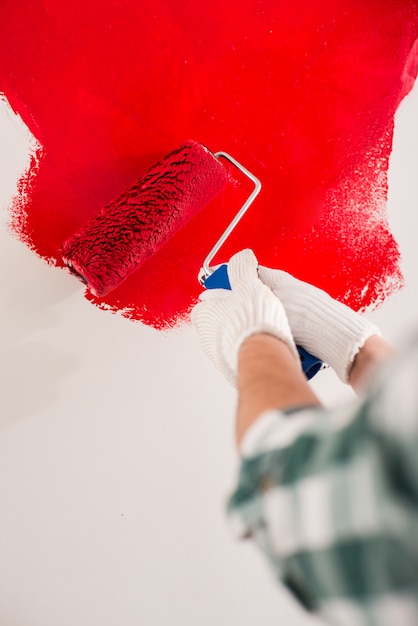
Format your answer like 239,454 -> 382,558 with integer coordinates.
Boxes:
258,265 -> 381,383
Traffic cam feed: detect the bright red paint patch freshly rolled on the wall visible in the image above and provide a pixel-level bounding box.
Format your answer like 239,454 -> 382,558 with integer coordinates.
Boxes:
0,0 -> 418,327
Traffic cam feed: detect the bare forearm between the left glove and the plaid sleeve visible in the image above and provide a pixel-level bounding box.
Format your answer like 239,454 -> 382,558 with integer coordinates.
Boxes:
236,334 -> 320,446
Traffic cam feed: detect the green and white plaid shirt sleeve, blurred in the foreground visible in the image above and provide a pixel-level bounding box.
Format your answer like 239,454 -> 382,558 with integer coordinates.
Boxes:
227,336 -> 418,626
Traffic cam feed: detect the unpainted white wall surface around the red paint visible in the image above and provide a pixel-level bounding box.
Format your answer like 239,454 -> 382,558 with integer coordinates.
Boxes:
0,80 -> 418,626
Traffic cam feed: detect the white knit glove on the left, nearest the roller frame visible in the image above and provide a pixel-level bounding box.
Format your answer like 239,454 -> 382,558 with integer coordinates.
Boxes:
192,250 -> 300,385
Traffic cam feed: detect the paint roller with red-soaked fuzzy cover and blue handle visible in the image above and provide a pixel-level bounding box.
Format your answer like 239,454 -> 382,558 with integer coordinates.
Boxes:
61,140 -> 322,378
